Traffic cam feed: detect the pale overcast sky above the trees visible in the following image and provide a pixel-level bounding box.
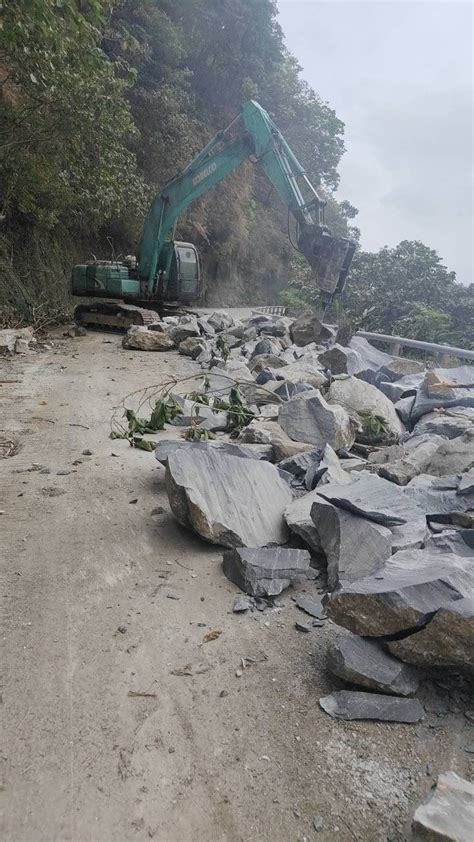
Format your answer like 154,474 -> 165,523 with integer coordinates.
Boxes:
278,0 -> 474,283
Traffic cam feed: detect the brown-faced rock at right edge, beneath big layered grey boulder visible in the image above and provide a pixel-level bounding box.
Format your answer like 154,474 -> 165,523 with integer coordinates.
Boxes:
387,596 -> 474,672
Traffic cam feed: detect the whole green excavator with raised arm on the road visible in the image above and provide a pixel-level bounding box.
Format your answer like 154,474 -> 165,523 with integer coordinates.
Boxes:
72,100 -> 355,328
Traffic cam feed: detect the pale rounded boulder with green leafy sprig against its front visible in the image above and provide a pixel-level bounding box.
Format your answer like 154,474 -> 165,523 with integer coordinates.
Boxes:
327,377 -> 403,443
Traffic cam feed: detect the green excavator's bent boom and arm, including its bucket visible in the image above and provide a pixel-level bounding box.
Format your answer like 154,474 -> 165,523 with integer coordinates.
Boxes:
138,100 -> 355,309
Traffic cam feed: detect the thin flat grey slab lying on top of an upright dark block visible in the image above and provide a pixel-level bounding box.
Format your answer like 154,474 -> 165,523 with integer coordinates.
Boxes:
319,471 -> 424,527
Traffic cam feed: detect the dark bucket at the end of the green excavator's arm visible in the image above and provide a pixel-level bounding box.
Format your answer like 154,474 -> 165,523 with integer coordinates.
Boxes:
298,225 -> 355,308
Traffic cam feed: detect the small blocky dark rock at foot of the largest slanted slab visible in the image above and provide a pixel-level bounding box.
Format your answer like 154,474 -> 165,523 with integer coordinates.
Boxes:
223,547 -> 310,596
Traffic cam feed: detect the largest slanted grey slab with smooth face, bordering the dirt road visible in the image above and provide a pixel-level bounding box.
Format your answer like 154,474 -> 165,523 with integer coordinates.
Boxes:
166,448 -> 293,547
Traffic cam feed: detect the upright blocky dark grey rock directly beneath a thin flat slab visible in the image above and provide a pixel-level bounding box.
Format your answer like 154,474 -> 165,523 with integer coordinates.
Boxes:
310,494 -> 392,590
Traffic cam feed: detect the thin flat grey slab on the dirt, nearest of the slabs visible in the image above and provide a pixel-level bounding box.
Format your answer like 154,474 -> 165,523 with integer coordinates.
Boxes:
319,690 -> 424,723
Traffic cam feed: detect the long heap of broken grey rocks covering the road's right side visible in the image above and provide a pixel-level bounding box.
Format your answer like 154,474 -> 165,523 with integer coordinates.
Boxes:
131,312 -> 474,722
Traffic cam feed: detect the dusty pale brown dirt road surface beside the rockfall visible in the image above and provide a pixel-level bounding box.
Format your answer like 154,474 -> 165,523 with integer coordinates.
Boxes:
0,332 -> 473,842
